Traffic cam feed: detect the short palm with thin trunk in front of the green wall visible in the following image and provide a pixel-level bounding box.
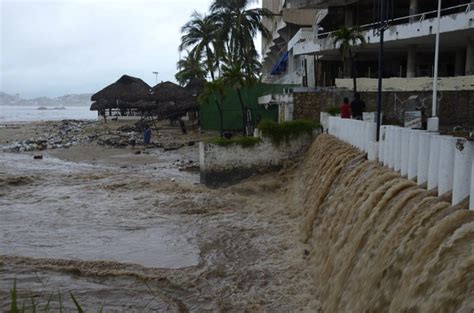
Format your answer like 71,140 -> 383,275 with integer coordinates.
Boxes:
221,59 -> 257,135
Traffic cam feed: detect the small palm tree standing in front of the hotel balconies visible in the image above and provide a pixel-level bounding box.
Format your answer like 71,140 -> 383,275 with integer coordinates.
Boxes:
331,25 -> 365,96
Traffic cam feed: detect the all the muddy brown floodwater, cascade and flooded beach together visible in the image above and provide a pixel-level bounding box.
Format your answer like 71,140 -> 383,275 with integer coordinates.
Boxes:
0,121 -> 474,313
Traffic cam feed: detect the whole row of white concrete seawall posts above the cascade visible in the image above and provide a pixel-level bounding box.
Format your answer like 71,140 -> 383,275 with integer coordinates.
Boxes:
328,117 -> 474,210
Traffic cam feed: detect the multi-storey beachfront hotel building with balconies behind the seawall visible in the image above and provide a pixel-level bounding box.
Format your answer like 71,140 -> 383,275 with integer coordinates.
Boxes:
259,0 -> 474,129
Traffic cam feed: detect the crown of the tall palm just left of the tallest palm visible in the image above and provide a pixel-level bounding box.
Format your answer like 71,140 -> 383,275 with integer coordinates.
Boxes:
179,11 -> 222,80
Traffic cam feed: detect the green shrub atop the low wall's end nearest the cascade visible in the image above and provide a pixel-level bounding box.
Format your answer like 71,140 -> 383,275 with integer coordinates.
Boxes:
257,120 -> 321,145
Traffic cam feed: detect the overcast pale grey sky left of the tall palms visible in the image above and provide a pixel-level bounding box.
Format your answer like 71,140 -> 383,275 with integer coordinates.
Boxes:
0,0 -> 260,98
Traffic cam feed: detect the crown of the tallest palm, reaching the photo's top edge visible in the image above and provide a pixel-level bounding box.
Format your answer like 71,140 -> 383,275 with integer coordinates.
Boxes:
210,0 -> 270,72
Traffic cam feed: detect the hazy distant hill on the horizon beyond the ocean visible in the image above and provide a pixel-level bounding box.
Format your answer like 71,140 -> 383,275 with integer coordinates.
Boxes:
0,91 -> 92,107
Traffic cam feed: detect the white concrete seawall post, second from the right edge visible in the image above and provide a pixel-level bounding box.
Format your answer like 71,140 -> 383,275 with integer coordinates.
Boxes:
438,136 -> 458,196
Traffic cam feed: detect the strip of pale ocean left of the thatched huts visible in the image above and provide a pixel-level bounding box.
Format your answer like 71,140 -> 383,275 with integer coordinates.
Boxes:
0,105 -> 97,123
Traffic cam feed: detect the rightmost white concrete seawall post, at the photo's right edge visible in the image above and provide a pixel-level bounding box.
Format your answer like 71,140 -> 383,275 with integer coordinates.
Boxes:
452,139 -> 474,205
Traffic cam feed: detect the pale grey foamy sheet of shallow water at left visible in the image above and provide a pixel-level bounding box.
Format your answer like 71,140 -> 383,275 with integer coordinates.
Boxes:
0,153 -> 199,268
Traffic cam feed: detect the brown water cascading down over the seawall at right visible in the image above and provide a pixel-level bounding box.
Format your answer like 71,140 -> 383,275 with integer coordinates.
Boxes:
292,135 -> 474,312
